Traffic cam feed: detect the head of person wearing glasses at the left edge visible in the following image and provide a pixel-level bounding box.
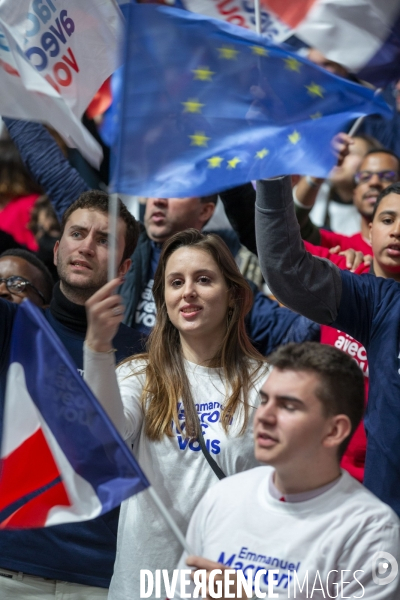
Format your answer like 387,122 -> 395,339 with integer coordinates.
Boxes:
0,248 -> 53,308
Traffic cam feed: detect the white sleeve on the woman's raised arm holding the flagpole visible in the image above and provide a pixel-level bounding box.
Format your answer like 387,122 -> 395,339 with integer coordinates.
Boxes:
83,344 -> 143,440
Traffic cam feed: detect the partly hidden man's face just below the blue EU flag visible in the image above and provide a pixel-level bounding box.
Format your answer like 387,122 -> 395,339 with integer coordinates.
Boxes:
144,198 -> 215,243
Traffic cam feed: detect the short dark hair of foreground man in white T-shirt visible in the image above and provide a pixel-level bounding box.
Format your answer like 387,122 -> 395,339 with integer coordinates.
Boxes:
267,342 -> 365,457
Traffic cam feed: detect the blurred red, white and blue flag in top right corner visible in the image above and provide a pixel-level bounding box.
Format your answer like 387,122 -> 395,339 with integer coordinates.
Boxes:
261,0 -> 400,87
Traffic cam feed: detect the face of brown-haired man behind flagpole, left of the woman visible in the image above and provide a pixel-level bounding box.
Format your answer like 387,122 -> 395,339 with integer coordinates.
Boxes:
54,208 -> 130,300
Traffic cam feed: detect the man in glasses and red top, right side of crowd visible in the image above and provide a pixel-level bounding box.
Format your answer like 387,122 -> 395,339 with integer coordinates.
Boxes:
294,149 -> 400,255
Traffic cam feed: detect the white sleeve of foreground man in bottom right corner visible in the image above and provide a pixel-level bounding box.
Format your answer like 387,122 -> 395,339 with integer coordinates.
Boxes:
337,521 -> 400,600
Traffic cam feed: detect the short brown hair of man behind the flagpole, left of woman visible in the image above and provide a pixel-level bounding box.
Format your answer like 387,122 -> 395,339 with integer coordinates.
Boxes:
61,190 -> 140,261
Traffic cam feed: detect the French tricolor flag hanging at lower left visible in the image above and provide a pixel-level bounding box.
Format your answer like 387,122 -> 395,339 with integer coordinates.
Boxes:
0,301 -> 149,529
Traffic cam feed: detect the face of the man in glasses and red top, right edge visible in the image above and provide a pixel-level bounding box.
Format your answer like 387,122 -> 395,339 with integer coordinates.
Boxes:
354,152 -> 399,218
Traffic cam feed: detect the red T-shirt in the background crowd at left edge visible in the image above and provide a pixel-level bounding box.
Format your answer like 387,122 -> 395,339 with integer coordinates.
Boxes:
0,194 -> 39,251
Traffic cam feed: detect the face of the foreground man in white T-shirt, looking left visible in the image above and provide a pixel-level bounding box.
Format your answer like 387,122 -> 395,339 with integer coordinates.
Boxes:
254,367 -> 335,471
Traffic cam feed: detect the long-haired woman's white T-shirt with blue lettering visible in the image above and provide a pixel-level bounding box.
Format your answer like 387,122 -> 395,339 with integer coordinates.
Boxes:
109,361 -> 267,600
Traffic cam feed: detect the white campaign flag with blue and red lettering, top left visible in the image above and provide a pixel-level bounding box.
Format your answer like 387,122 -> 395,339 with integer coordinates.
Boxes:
0,0 -> 123,165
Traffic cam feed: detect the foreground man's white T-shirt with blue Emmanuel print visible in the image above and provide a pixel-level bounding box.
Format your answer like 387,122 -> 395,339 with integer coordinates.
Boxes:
173,467 -> 400,600
